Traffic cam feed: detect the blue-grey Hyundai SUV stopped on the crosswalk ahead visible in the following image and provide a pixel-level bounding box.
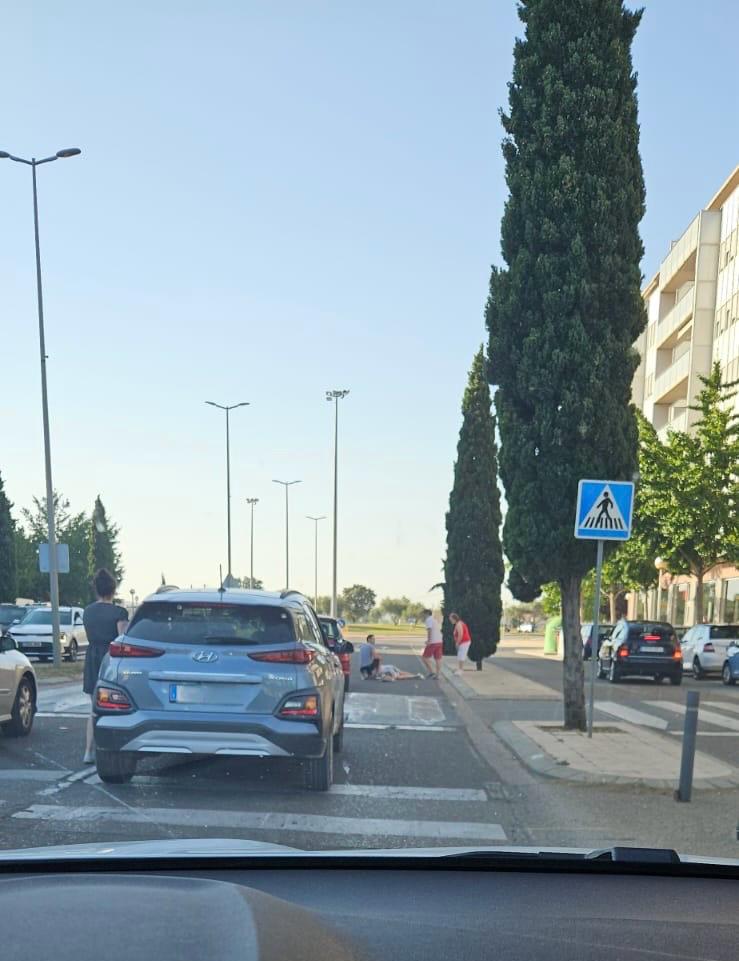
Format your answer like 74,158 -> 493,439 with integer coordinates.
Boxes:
94,590 -> 344,791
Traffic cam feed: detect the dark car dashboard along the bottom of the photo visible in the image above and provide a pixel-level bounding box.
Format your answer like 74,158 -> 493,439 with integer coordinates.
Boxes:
0,859 -> 739,961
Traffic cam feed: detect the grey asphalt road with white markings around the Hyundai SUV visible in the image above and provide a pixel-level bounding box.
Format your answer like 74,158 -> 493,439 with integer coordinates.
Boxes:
0,638 -> 739,857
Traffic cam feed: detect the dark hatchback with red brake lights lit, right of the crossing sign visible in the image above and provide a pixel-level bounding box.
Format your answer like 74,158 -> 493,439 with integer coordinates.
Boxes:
598,620 -> 683,685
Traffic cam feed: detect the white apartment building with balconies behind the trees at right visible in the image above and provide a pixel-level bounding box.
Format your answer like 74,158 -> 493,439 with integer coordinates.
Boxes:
629,166 -> 739,626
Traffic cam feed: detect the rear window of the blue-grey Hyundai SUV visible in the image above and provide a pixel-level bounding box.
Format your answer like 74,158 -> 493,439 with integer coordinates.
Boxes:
126,601 -> 295,646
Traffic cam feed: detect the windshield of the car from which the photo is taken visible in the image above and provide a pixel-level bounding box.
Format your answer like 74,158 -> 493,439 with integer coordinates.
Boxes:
0,0 -> 739,872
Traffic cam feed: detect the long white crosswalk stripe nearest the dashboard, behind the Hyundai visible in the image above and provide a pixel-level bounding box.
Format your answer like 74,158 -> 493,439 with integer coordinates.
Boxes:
12,804 -> 506,842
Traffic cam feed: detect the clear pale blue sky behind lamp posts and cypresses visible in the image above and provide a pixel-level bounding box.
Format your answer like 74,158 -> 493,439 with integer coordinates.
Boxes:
0,0 -> 739,600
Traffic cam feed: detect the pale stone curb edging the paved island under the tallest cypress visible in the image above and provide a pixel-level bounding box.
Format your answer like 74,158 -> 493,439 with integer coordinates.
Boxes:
493,721 -> 739,791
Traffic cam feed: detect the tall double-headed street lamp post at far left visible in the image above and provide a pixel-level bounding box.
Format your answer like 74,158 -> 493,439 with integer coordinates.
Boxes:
0,147 -> 82,667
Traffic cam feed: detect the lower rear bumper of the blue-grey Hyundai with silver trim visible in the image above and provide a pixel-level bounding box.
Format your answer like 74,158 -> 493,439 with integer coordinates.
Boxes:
95,711 -> 326,758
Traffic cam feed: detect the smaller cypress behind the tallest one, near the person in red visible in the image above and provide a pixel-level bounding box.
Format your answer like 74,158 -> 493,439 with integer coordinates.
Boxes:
444,347 -> 503,663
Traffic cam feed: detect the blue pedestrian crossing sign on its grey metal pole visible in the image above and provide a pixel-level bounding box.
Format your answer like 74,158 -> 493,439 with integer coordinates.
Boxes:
575,480 -> 634,737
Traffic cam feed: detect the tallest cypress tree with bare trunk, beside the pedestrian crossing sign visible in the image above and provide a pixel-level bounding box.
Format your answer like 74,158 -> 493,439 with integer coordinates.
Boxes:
487,0 -> 645,729
